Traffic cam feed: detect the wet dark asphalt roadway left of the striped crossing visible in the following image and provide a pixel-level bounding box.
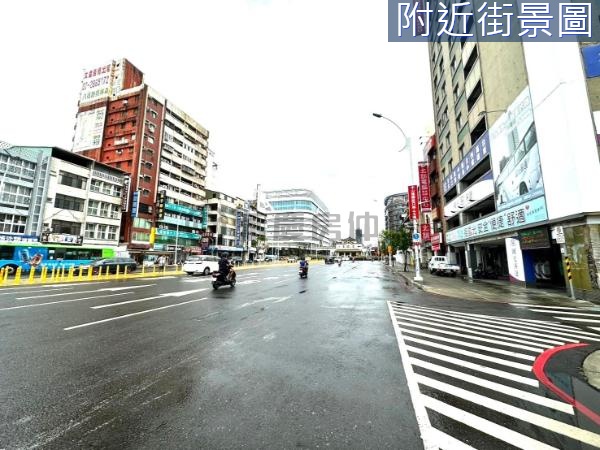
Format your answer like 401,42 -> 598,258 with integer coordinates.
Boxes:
0,262 -> 422,449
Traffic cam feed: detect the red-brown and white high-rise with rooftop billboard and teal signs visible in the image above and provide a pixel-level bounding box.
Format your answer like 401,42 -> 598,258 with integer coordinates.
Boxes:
73,59 -> 209,260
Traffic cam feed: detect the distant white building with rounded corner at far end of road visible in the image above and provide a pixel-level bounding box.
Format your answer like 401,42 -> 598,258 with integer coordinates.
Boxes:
264,189 -> 331,254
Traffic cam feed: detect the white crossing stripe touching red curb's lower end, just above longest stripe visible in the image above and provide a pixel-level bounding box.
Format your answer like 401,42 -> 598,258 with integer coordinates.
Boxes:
410,358 -> 575,415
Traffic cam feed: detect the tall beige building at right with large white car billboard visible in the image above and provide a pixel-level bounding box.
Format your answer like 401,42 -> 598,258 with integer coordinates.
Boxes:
429,22 -> 600,298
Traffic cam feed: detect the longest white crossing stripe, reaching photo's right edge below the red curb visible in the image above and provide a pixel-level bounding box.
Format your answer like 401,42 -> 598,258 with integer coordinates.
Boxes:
416,375 -> 600,447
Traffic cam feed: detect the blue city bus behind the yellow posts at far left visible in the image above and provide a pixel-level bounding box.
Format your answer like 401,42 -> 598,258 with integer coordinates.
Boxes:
0,242 -> 115,273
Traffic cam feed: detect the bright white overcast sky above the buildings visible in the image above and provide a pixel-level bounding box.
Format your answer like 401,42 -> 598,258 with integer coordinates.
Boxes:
0,0 -> 432,246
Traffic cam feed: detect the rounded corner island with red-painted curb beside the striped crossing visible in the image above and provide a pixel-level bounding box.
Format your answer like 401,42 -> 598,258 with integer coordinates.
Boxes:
533,342 -> 600,432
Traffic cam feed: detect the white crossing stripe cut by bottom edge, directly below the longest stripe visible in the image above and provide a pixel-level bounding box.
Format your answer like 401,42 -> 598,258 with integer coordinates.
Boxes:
423,395 -> 557,450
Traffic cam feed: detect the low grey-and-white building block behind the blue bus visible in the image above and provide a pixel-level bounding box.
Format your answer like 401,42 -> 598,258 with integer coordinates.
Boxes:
0,143 -> 125,247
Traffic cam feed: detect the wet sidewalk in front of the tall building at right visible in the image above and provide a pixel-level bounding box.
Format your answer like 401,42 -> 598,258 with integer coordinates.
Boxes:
385,264 -> 596,306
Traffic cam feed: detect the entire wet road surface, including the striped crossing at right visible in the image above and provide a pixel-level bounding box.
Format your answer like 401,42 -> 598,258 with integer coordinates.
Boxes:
0,262 -> 600,450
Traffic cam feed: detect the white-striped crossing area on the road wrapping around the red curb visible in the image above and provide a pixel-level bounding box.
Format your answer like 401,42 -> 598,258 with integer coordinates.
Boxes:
388,302 -> 600,450
